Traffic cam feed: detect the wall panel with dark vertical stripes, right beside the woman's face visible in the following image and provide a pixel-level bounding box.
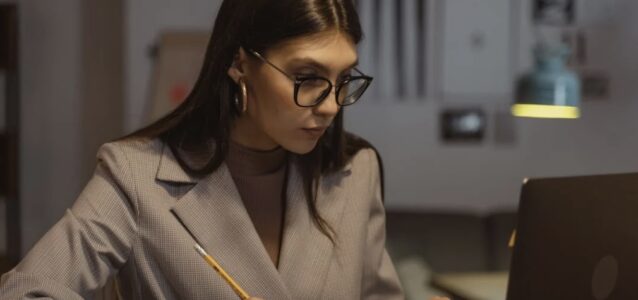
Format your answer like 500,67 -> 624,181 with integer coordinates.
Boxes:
358,0 -> 430,102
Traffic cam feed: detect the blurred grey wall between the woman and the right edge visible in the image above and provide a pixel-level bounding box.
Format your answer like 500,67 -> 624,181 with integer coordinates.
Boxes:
346,0 -> 638,213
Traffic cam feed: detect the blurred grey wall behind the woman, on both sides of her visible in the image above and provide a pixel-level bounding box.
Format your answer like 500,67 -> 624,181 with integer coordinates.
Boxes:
5,0 -> 638,251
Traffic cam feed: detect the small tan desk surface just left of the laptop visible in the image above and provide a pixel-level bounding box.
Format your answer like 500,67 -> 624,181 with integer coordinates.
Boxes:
432,272 -> 508,300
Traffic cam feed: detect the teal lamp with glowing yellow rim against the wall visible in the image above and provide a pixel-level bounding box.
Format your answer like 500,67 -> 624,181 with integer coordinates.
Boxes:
512,44 -> 580,119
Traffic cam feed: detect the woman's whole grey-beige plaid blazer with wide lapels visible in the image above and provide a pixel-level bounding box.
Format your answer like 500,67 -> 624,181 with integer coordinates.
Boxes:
0,139 -> 403,300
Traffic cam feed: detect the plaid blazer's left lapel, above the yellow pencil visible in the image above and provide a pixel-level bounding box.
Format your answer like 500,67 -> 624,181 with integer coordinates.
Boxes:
172,158 -> 290,299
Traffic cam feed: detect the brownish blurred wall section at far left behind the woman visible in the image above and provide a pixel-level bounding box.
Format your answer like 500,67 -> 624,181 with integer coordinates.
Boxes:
0,0 -> 124,252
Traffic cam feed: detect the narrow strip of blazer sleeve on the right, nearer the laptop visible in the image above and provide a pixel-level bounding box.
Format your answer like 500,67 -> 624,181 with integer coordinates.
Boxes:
362,150 -> 404,300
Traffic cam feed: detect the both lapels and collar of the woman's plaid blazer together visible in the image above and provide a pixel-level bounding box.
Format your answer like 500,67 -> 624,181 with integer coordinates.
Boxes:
157,146 -> 352,300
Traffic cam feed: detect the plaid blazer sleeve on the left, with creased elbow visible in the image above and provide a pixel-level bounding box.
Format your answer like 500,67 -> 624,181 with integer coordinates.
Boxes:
0,144 -> 137,299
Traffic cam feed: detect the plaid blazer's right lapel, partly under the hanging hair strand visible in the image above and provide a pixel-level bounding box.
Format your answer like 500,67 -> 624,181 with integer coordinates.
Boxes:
279,164 -> 349,299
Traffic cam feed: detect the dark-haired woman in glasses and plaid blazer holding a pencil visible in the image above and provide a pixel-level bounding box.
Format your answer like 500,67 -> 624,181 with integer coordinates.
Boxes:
0,0 -> 402,300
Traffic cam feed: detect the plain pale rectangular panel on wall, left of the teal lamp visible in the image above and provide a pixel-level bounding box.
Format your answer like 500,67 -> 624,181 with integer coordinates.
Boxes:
435,0 -> 513,98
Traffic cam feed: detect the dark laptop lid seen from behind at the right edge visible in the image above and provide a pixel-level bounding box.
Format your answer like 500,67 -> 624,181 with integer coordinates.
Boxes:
507,173 -> 638,300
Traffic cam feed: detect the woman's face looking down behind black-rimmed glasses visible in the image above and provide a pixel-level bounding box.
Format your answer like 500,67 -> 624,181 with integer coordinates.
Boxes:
229,31 -> 357,154
